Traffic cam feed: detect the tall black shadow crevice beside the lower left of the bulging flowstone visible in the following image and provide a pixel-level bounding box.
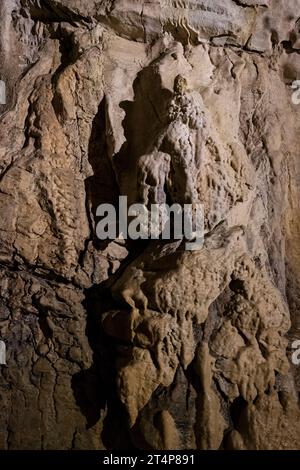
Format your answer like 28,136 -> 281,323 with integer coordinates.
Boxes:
72,283 -> 134,450
